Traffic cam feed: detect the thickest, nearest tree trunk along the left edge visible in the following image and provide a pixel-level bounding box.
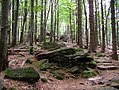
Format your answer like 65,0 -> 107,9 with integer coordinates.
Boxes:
0,0 -> 9,72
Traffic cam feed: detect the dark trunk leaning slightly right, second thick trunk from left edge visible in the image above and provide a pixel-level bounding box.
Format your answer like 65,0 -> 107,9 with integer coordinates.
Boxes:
12,0 -> 19,46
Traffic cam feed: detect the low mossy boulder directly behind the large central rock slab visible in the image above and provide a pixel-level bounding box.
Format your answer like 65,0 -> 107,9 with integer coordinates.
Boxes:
41,42 -> 65,51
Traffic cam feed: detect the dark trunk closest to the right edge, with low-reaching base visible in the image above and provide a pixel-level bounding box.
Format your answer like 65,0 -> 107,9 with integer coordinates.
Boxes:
110,0 -> 118,60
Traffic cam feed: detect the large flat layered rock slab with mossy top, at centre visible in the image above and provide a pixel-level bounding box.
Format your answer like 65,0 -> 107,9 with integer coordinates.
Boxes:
36,48 -> 93,65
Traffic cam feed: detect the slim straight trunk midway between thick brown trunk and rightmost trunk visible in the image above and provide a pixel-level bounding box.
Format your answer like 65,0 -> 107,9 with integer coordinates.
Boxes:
101,0 -> 105,53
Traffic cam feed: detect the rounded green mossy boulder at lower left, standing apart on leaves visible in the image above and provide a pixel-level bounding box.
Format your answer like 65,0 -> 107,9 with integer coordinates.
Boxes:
5,67 -> 40,83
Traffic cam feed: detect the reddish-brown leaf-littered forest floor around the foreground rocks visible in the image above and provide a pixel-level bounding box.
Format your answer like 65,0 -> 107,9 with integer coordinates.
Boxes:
0,43 -> 119,90
